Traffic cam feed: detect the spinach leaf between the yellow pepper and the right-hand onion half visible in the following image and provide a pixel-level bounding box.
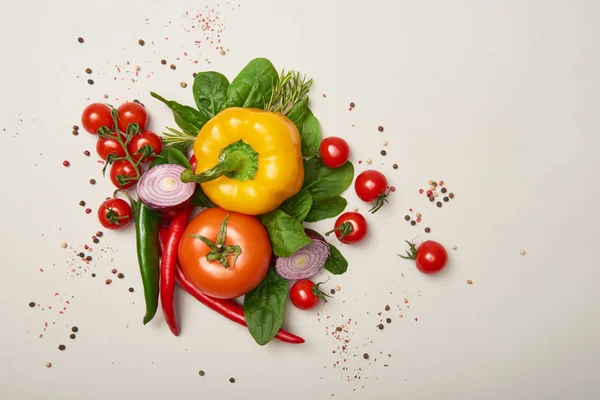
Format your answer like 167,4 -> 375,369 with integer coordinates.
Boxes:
260,210 -> 312,257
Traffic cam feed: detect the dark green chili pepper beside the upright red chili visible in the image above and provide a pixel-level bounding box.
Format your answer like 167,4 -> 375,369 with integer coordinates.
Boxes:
135,201 -> 160,325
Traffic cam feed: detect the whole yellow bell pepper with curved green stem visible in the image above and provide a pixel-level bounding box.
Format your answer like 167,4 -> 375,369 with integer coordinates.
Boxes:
181,107 -> 304,215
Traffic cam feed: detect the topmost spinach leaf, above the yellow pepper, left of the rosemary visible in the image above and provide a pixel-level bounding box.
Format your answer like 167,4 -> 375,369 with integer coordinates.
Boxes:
227,58 -> 279,109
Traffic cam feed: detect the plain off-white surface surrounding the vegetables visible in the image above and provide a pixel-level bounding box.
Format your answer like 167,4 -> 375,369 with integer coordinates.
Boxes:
0,0 -> 600,399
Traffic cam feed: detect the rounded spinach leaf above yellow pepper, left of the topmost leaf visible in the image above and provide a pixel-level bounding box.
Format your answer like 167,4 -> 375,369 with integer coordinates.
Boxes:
192,71 -> 229,119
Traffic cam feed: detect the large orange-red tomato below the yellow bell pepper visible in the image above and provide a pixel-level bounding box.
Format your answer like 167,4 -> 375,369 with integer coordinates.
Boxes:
179,207 -> 271,299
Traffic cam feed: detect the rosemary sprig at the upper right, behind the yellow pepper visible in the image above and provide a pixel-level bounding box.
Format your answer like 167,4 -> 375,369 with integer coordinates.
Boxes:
265,70 -> 313,115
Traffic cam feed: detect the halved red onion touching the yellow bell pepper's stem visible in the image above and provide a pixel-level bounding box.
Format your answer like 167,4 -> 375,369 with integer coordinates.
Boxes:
137,164 -> 196,212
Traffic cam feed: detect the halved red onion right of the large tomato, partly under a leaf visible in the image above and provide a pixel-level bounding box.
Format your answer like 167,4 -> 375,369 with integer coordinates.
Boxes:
275,229 -> 329,280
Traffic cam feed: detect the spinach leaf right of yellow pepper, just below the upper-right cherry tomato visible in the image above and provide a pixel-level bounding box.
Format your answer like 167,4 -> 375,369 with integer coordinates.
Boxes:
302,157 -> 354,201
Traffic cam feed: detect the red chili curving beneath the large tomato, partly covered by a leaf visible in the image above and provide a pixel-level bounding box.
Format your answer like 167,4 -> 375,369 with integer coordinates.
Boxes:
160,228 -> 304,344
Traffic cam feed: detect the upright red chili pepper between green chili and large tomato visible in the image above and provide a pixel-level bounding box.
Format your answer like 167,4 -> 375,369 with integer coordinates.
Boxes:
160,205 -> 193,336
